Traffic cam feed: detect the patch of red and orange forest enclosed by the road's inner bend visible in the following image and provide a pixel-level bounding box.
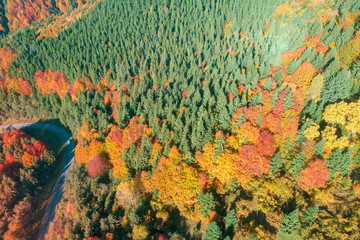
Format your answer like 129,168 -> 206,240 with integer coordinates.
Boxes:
0,129 -> 55,240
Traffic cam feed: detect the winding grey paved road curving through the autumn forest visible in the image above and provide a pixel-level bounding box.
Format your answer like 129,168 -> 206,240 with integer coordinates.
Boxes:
0,123 -> 75,240
